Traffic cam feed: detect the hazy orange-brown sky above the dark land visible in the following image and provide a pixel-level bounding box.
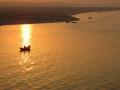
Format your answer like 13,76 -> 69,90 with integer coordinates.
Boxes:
0,0 -> 120,6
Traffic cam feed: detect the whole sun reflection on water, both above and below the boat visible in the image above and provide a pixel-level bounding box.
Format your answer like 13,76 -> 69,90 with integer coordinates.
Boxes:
18,24 -> 34,73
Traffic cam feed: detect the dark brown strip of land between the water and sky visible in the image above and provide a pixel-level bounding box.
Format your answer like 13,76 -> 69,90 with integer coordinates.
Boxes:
0,7 -> 120,25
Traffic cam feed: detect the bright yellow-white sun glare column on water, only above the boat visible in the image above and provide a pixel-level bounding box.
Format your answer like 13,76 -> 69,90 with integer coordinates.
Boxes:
21,24 -> 32,46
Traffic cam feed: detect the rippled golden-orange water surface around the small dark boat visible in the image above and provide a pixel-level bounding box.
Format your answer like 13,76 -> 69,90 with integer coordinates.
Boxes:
0,11 -> 120,90
